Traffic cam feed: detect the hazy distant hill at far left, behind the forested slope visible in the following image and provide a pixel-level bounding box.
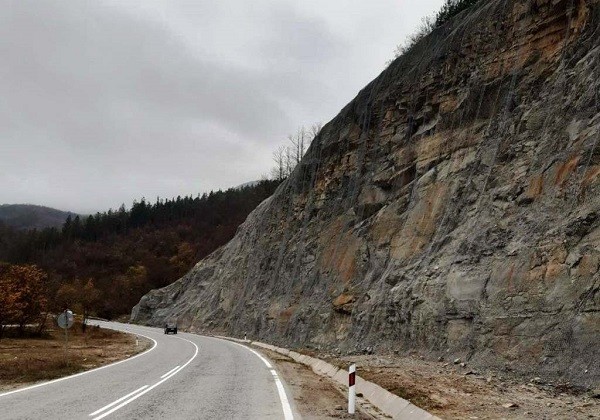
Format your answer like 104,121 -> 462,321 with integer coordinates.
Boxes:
0,204 -> 75,230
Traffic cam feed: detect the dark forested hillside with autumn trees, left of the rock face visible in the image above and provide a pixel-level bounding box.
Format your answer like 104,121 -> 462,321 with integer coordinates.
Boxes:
0,180 -> 281,328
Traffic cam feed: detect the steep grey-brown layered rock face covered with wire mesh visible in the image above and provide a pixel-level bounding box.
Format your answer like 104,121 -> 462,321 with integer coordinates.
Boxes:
132,0 -> 600,385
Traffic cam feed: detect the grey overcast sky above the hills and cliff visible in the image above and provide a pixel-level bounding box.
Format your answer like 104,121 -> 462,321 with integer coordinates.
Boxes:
0,0 -> 443,213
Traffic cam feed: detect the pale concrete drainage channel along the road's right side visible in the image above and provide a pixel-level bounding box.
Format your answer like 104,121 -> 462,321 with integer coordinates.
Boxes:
217,336 -> 440,420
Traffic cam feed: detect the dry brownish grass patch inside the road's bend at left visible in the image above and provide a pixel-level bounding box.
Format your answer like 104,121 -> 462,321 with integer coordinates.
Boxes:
0,324 -> 150,390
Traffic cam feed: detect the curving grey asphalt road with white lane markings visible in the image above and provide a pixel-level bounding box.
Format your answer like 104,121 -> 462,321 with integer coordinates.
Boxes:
0,321 -> 298,420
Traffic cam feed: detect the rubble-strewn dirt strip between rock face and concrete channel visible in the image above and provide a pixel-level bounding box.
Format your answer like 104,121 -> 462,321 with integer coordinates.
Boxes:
310,352 -> 600,420
